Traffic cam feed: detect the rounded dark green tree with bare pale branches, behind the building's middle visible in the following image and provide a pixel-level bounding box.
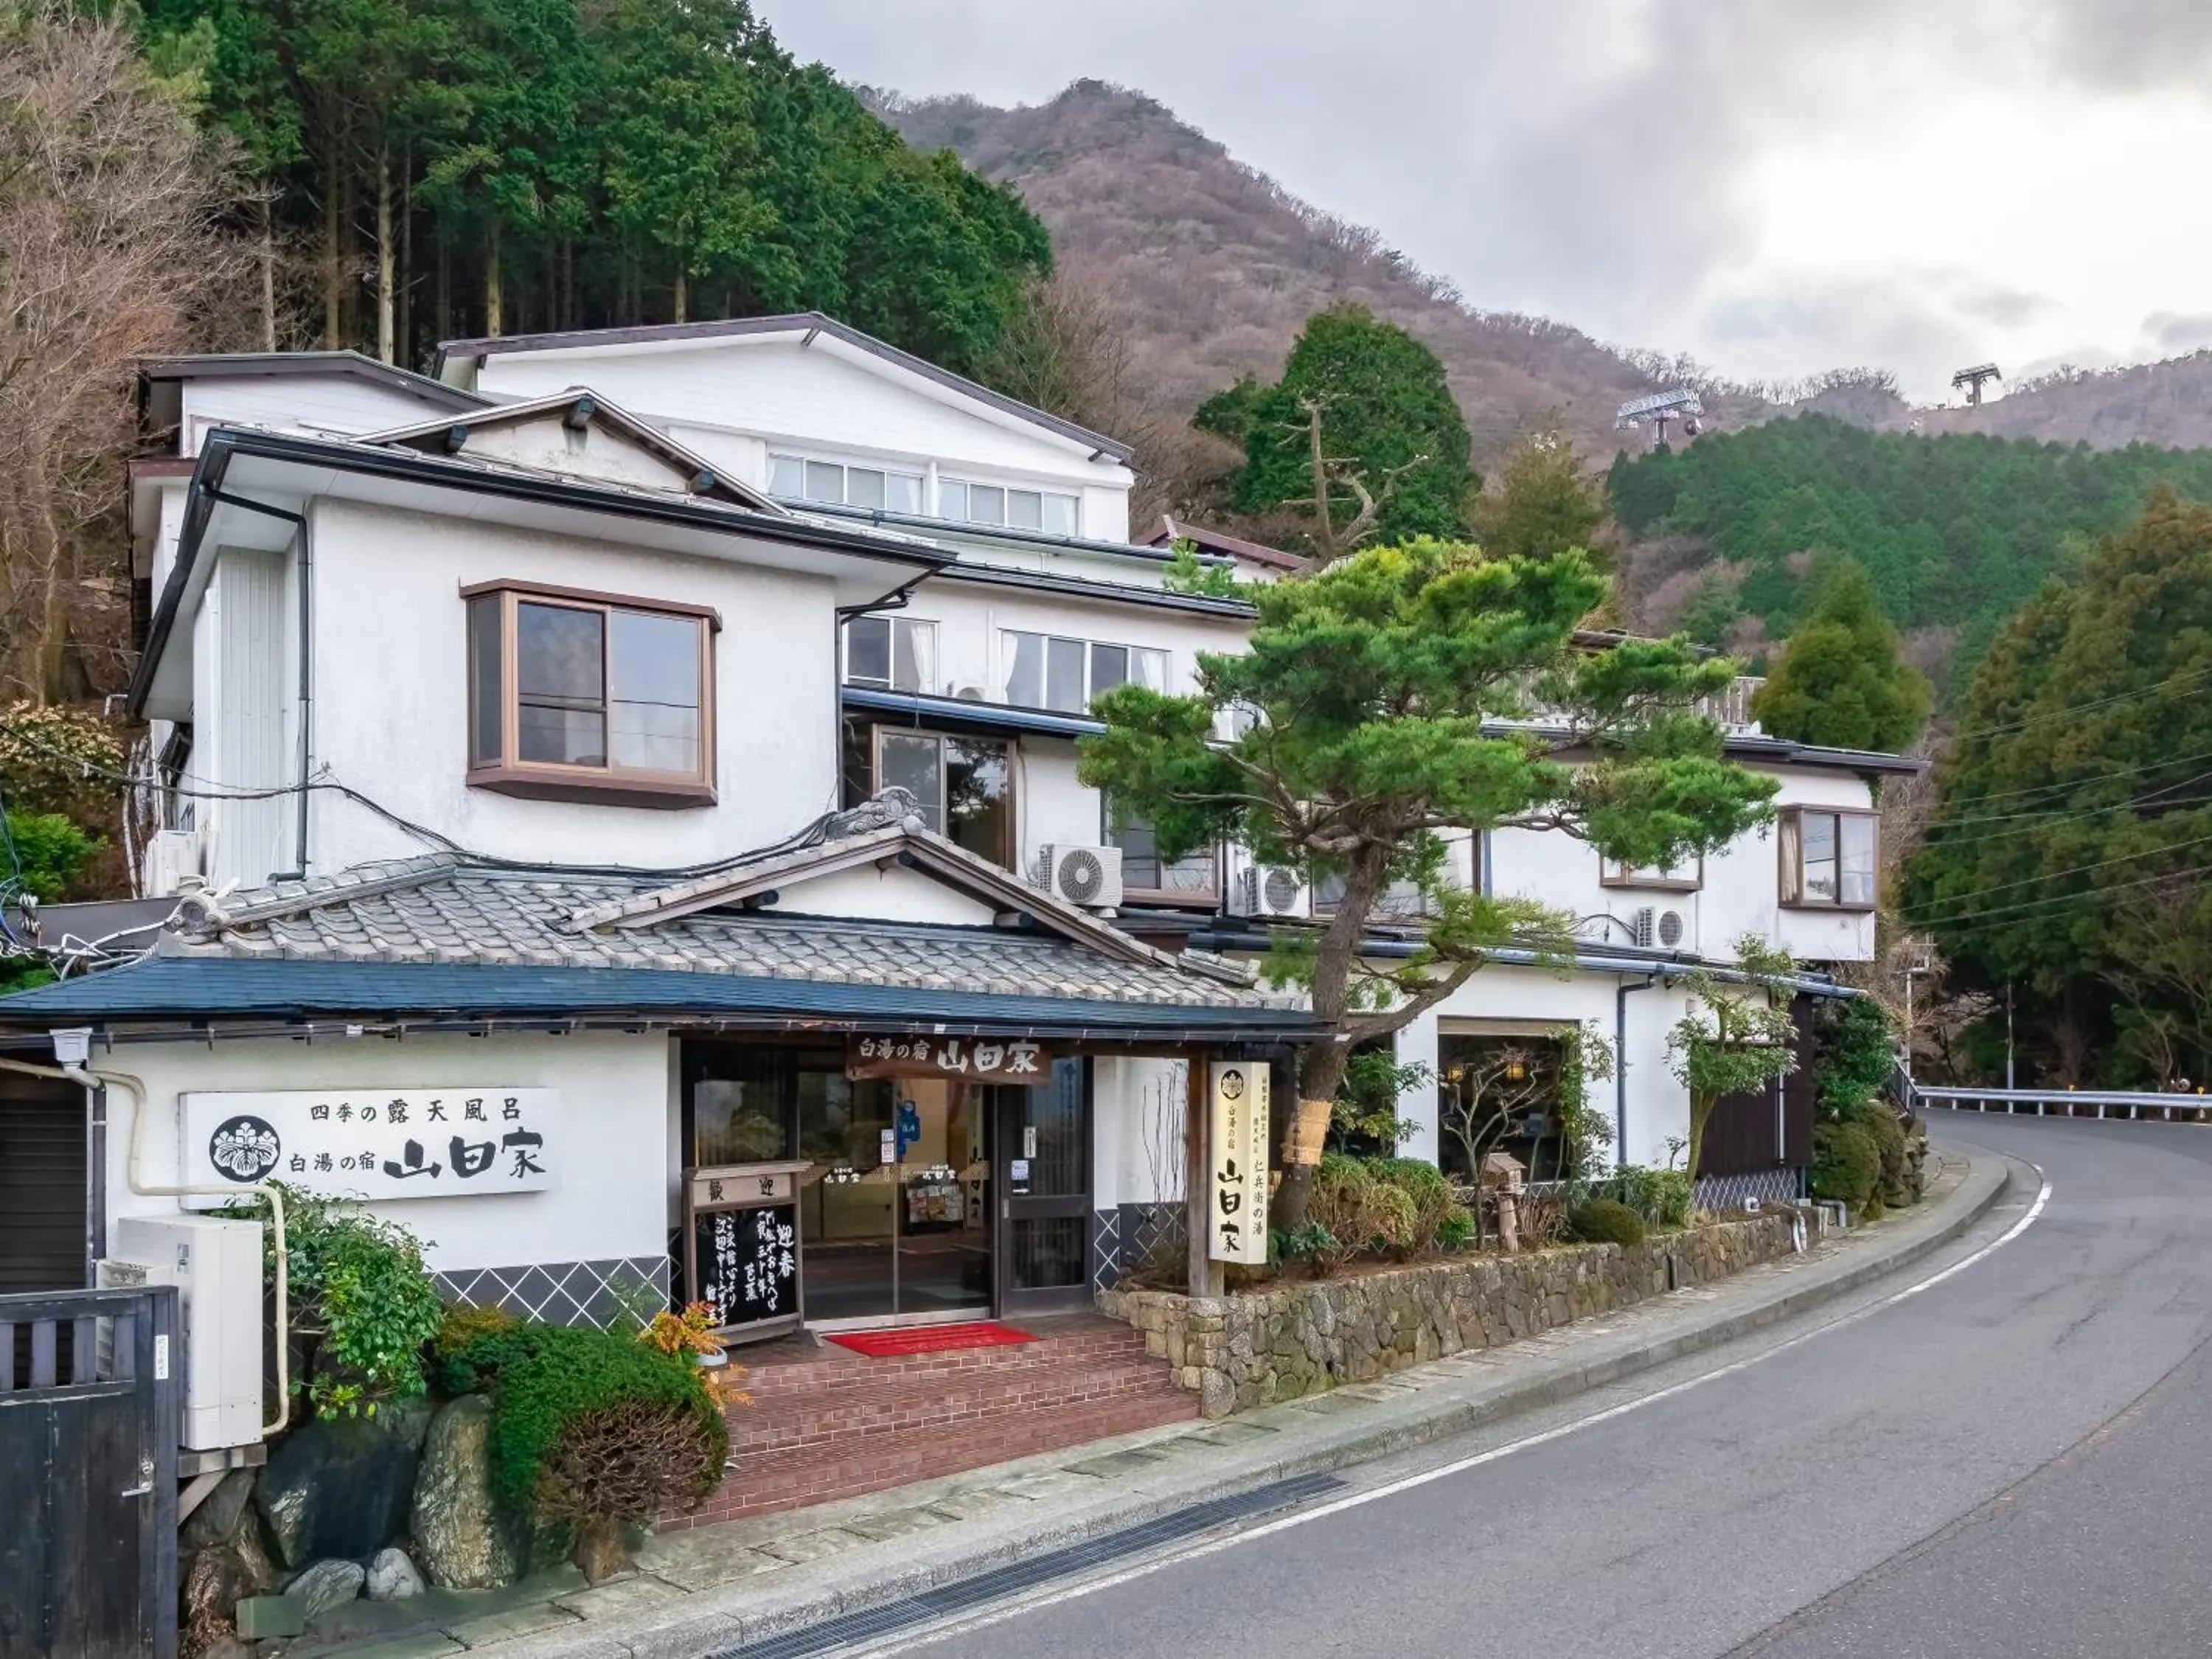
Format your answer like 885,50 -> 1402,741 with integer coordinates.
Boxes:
1194,303 -> 1480,560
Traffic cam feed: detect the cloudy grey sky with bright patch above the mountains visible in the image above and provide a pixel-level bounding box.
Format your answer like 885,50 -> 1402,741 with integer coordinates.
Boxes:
759,0 -> 2212,400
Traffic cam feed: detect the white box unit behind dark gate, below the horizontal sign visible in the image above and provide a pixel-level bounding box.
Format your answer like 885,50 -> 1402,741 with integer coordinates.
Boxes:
97,1214 -> 261,1451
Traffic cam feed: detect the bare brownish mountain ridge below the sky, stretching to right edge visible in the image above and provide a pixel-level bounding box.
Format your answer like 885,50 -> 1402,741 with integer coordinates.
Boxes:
869,80 -> 2212,469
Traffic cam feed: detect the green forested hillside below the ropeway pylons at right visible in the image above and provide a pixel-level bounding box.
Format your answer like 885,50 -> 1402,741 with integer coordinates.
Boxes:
1610,416 -> 2212,681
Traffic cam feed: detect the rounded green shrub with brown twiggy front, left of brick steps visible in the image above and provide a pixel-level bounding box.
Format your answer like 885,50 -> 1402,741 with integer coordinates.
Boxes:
438,1325 -> 730,1520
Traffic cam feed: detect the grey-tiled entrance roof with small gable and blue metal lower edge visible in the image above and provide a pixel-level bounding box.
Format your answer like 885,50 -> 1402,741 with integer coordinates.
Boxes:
0,814 -> 1283,1035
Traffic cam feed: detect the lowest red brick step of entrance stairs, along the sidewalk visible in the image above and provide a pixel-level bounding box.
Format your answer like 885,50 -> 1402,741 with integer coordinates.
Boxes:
690,1387 -> 1199,1528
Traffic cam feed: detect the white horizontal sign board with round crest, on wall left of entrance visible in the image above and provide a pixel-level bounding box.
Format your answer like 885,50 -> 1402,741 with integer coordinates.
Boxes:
181,1084 -> 562,1203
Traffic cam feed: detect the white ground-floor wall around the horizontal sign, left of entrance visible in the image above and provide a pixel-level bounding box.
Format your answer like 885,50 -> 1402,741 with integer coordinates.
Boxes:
102,1033 -> 675,1272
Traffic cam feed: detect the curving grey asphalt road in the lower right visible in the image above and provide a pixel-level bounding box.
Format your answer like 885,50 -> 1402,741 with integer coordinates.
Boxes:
876,1115 -> 2212,1659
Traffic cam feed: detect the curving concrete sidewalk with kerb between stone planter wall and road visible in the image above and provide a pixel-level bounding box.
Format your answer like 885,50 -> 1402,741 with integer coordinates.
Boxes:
303,1146 -> 2011,1659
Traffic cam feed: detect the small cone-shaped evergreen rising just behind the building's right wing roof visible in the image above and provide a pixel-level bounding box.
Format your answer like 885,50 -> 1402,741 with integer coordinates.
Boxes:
1752,560 -> 1935,750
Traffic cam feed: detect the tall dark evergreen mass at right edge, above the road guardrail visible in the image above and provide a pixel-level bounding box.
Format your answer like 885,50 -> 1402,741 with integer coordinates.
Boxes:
1905,491 -> 2212,1082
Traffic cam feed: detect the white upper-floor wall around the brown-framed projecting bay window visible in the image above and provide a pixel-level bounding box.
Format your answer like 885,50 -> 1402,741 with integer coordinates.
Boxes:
288,500 -> 838,872
